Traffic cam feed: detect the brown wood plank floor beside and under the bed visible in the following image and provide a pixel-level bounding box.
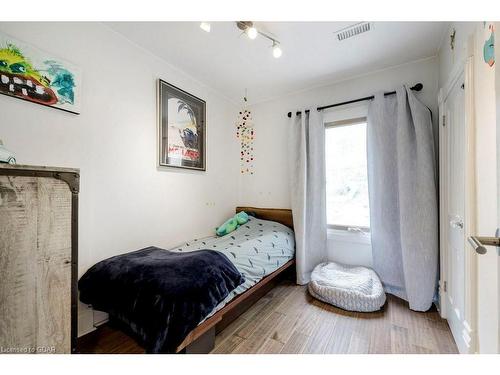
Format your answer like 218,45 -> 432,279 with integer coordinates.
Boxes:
78,281 -> 457,354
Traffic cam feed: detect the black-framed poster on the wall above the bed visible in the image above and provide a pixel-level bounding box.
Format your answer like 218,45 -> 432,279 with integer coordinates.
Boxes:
158,79 -> 206,171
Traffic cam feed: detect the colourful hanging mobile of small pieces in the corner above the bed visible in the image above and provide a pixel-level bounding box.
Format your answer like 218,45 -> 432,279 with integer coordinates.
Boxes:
236,109 -> 255,175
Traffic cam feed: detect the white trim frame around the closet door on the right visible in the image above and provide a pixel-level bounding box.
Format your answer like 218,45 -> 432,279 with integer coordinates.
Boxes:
438,35 -> 478,353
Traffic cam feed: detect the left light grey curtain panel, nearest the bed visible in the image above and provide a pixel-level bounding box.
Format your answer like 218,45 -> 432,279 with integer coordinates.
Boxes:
287,109 -> 327,284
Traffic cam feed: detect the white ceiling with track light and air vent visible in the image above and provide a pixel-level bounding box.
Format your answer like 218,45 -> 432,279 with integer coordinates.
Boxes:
107,22 -> 446,103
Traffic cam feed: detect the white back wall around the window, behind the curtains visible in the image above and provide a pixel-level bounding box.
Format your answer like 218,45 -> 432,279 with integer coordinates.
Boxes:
244,58 -> 438,266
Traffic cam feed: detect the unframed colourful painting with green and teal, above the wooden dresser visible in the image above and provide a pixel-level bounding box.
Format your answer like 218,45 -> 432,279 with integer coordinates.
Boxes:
0,33 -> 81,114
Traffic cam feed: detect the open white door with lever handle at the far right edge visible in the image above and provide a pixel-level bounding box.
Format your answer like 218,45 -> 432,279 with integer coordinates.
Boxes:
474,22 -> 500,353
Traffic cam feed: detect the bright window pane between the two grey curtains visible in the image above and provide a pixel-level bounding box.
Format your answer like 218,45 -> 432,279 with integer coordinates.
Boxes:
325,118 -> 370,230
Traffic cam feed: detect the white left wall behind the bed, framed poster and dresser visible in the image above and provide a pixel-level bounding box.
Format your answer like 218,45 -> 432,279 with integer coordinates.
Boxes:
0,23 -> 239,332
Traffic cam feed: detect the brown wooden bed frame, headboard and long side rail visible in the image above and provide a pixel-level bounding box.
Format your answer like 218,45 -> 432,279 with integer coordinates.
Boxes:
177,207 -> 295,354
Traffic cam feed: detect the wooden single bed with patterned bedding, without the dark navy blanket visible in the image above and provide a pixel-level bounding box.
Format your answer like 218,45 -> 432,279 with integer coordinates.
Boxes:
78,207 -> 295,353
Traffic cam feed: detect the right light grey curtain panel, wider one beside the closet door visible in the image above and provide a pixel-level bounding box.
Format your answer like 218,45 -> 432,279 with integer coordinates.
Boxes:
367,87 -> 438,311
